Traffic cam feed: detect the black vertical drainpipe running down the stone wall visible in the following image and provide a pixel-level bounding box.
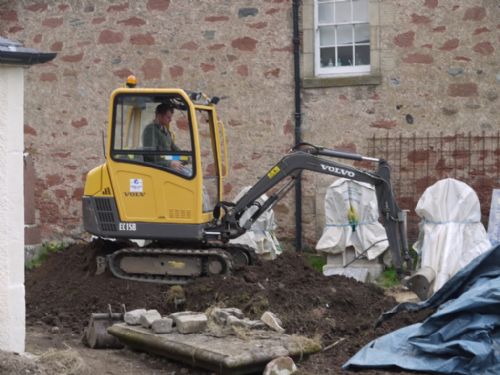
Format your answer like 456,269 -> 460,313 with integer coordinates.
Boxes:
292,0 -> 302,251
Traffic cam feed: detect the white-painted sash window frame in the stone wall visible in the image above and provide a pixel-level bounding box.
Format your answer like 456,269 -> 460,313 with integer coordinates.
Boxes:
314,0 -> 372,77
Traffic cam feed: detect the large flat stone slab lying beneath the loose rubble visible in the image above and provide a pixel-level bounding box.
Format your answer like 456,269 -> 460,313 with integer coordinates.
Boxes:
108,323 -> 321,375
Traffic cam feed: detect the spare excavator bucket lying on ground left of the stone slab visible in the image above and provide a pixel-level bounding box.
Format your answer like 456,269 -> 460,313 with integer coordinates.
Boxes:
82,305 -> 125,349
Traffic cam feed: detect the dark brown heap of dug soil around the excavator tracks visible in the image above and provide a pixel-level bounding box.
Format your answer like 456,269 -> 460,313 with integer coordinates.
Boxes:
26,241 -> 428,375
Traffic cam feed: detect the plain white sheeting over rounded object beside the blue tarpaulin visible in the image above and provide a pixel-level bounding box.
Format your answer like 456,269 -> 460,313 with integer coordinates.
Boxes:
414,178 -> 491,292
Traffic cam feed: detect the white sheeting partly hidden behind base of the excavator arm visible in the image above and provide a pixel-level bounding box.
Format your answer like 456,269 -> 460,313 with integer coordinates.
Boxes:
229,186 -> 282,259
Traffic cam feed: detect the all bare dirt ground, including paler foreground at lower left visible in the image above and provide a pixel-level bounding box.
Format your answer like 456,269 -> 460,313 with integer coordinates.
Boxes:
0,241 -> 429,375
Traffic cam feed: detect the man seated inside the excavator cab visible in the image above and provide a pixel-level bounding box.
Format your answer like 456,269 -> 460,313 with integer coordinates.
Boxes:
142,103 -> 183,173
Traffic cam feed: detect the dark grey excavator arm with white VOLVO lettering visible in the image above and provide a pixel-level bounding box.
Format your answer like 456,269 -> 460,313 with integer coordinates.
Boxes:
206,143 -> 411,274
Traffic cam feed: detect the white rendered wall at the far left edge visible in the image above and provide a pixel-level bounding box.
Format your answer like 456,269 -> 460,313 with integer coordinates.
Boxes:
0,65 -> 26,352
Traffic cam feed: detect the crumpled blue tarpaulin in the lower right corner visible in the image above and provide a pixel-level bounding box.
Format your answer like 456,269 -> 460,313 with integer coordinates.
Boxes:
342,246 -> 500,375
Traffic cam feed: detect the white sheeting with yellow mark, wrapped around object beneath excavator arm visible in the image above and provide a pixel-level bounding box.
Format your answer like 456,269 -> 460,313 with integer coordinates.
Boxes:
316,178 -> 389,260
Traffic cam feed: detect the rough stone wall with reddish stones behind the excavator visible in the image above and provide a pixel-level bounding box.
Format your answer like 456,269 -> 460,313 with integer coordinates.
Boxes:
0,0 -> 500,245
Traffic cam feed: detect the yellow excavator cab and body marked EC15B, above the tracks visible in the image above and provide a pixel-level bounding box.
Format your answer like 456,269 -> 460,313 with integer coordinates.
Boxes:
83,79 -> 227,241
